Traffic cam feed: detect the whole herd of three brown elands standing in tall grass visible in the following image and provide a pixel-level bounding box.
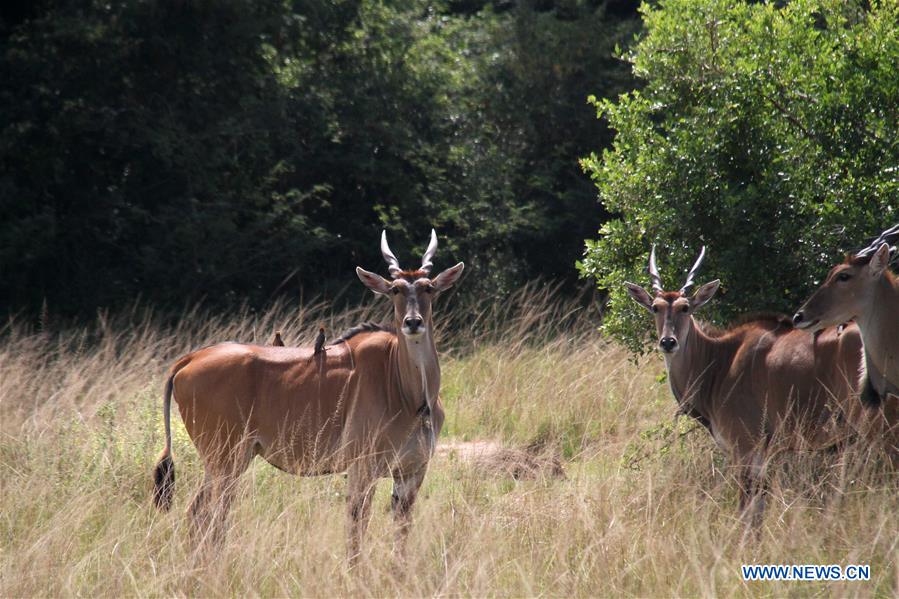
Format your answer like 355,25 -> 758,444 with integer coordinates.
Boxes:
153,225 -> 899,563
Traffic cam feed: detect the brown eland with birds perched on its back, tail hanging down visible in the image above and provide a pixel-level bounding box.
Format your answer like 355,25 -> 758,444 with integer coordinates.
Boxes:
154,231 -> 464,559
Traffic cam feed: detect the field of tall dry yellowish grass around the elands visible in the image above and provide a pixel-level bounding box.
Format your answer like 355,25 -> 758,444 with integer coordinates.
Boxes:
0,290 -> 899,597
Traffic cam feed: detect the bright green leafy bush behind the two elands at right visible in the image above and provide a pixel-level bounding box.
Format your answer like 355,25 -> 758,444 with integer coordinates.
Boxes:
580,0 -> 899,349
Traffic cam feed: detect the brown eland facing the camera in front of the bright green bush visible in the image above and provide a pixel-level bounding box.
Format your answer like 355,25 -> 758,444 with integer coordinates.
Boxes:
626,247 -> 861,526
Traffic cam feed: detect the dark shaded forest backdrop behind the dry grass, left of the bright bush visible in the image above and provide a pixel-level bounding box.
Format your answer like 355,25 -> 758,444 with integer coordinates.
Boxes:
0,0 -> 638,313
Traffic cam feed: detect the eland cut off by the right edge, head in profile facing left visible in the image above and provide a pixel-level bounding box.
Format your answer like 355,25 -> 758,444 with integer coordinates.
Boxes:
793,224 -> 899,463
